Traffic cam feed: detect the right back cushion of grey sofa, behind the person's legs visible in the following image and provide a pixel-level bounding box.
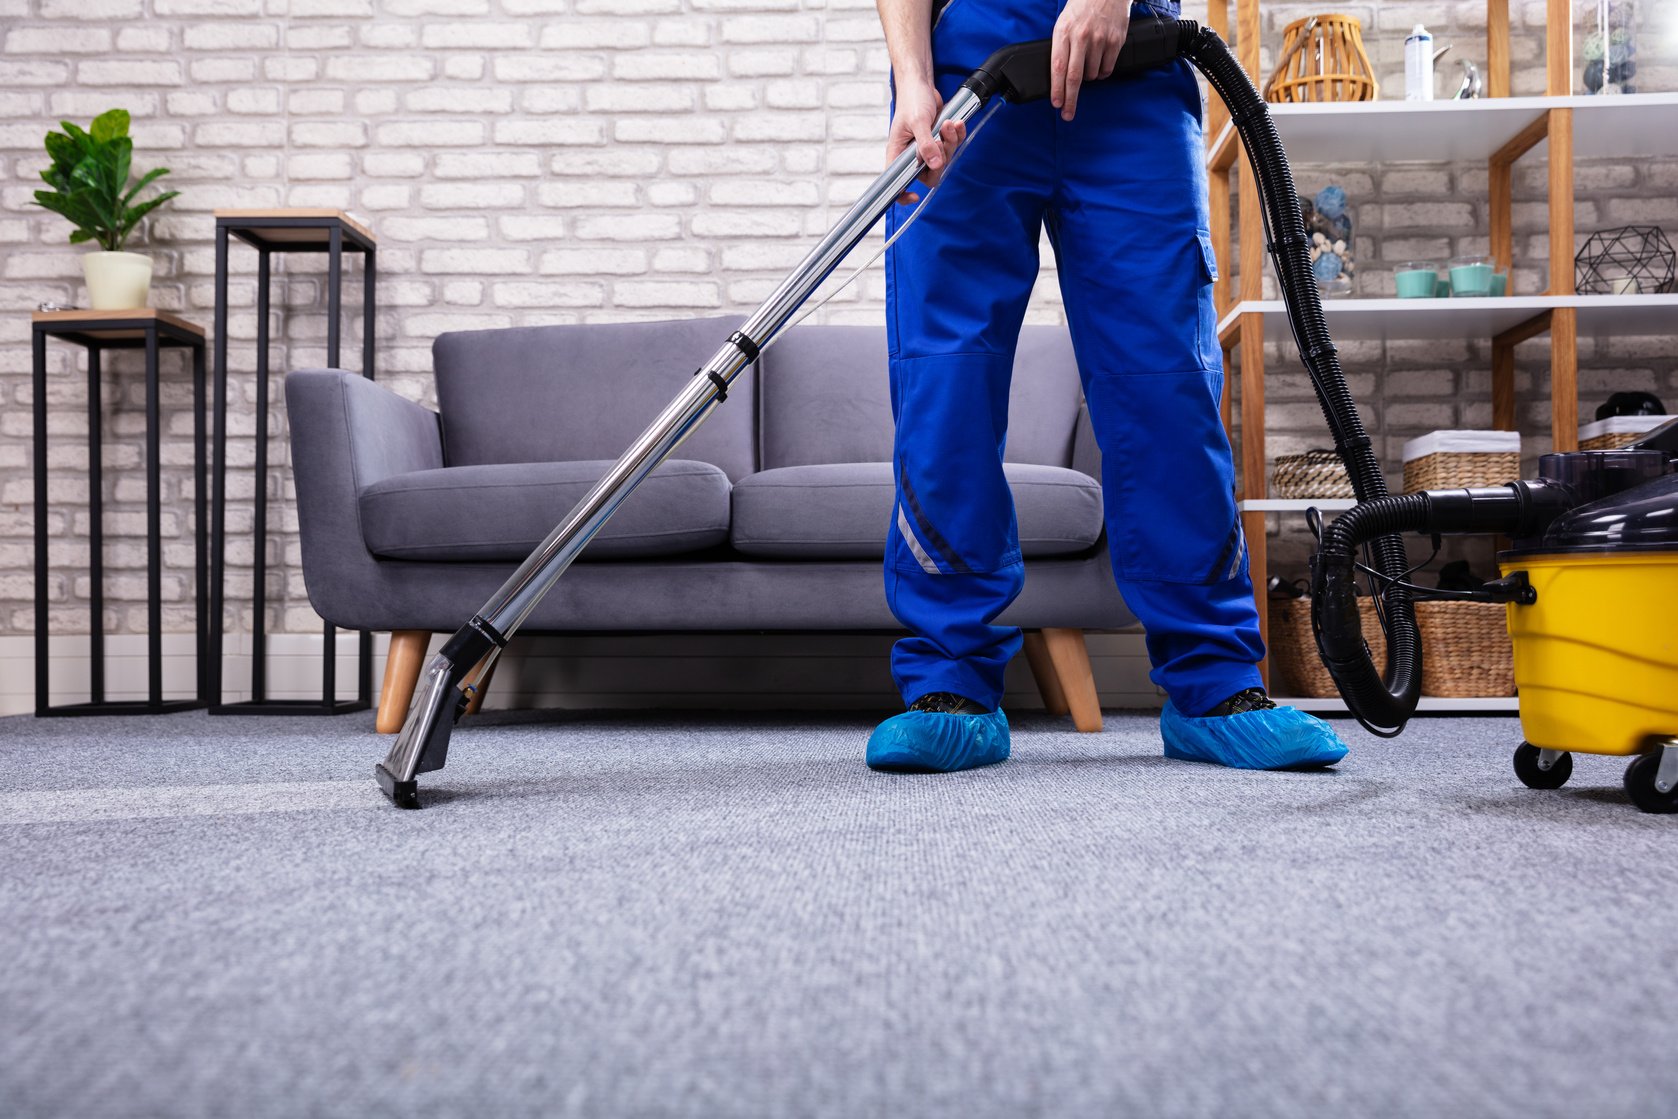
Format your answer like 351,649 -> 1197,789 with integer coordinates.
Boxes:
758,325 -> 1082,470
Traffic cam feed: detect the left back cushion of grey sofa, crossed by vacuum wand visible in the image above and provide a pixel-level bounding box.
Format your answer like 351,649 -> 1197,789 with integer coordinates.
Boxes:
433,315 -> 757,480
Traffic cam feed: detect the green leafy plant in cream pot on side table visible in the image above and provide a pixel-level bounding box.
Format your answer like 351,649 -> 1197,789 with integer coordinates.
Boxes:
35,109 -> 180,310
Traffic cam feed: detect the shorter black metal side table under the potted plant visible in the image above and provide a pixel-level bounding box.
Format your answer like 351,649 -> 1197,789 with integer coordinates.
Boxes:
30,307 -> 211,715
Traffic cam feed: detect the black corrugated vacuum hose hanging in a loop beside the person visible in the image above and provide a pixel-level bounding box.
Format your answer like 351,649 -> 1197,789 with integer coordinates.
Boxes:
1181,28 -> 1421,736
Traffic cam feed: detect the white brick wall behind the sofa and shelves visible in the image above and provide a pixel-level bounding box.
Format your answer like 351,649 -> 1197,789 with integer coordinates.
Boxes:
0,0 -> 1678,677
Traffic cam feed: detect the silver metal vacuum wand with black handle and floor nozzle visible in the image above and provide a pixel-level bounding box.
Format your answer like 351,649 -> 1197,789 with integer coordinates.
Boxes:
374,20 -> 1198,809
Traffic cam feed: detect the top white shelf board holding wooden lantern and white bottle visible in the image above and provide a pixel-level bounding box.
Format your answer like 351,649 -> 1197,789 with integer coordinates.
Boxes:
1218,94 -> 1678,164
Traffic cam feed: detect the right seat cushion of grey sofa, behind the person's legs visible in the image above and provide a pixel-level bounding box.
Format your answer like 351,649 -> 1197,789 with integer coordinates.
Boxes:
730,463 -> 1101,559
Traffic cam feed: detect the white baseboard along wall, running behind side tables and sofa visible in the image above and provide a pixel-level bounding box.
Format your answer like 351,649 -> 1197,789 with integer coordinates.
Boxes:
0,632 -> 1161,715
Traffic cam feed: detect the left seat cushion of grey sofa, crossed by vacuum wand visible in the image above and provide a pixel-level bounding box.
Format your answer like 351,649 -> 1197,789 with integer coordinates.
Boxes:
359,458 -> 728,560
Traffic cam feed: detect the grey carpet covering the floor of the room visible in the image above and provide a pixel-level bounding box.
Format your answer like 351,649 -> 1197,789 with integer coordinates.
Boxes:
0,713 -> 1678,1117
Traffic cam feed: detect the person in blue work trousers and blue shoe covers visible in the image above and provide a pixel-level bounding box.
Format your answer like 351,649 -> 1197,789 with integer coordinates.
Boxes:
868,0 -> 1346,772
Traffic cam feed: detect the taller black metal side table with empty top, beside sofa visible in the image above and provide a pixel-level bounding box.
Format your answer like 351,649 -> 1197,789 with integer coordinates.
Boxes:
210,210 -> 378,715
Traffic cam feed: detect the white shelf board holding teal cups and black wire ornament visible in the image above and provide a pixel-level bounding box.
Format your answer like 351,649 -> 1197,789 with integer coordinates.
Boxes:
1218,295 -> 1678,342
